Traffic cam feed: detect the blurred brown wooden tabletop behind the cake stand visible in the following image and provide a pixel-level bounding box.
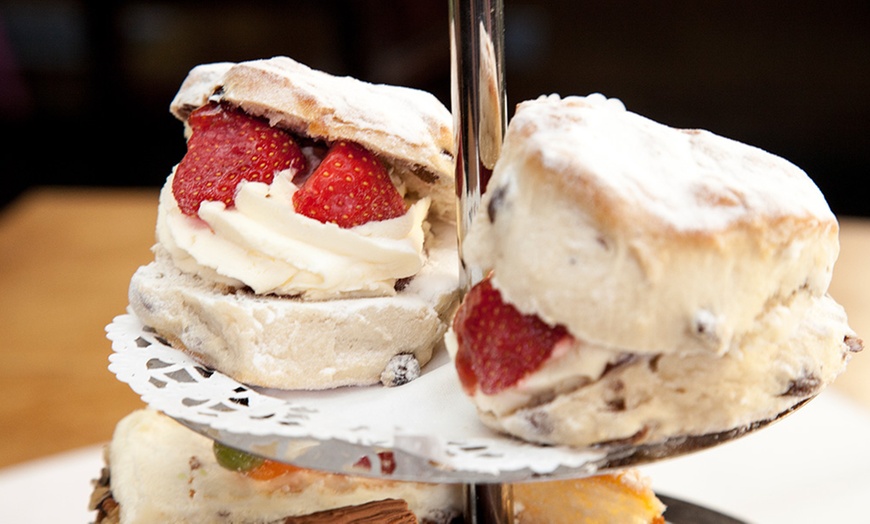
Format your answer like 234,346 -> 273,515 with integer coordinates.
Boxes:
0,188 -> 870,467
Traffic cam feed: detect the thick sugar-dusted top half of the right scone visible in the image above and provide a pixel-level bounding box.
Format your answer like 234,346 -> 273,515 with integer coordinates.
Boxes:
464,95 -> 839,354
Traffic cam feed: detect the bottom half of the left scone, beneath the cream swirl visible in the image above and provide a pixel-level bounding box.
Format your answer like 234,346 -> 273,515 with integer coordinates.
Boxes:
129,231 -> 458,390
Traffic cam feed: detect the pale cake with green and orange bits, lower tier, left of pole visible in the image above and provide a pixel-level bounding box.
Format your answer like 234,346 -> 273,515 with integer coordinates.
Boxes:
91,409 -> 462,524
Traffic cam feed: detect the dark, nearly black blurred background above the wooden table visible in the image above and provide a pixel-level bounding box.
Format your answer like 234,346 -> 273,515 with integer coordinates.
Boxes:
0,0 -> 870,216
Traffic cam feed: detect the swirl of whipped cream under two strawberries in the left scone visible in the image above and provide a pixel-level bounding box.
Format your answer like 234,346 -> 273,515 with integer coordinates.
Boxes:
157,170 -> 430,300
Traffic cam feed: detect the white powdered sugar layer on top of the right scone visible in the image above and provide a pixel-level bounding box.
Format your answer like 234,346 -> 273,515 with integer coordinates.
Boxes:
515,94 -> 833,230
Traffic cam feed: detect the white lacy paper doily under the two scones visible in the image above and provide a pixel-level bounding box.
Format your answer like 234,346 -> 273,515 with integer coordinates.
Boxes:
106,314 -> 620,482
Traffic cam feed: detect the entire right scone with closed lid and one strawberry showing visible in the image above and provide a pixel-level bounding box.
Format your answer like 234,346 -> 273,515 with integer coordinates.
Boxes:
447,94 -> 862,447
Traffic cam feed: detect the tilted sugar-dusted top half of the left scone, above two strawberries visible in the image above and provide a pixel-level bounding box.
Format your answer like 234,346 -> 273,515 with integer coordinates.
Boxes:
170,56 -> 455,220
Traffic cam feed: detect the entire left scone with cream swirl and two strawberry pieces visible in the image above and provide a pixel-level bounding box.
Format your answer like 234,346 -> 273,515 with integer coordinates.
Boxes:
129,57 -> 458,389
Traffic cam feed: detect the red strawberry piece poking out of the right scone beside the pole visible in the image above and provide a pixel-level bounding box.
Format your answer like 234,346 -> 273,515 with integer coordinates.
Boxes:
453,278 -> 570,395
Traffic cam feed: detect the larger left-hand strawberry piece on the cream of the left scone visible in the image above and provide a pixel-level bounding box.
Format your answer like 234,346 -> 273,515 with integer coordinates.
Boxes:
172,104 -> 306,216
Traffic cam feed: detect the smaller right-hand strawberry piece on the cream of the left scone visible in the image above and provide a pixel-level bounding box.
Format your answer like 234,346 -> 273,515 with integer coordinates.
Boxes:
293,142 -> 406,228
